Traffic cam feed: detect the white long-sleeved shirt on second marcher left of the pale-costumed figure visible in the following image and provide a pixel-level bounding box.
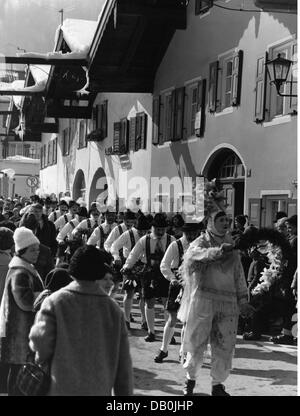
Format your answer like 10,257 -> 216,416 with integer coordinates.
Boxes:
124,233 -> 176,269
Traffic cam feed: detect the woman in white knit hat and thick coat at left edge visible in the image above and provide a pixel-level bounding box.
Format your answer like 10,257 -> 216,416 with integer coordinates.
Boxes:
0,227 -> 44,396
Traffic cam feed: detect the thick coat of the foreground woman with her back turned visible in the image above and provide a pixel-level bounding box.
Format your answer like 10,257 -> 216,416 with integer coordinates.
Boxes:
29,281 -> 133,396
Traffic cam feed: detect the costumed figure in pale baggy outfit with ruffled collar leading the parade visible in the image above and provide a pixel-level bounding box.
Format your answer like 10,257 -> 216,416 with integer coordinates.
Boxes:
178,209 -> 252,396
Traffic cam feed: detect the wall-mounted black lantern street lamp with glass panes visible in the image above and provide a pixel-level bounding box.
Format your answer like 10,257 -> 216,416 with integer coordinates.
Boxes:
265,53 -> 297,97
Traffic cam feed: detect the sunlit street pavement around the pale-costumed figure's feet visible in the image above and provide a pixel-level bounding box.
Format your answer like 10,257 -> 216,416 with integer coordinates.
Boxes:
130,302 -> 297,396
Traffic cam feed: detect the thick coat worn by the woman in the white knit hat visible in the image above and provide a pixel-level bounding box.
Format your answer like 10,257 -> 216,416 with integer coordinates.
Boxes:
0,256 -> 44,364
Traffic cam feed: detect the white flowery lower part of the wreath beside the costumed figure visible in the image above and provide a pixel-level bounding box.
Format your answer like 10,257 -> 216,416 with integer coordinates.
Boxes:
252,243 -> 283,295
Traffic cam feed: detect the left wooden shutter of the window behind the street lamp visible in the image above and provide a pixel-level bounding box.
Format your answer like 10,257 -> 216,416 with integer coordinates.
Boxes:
254,52 -> 268,123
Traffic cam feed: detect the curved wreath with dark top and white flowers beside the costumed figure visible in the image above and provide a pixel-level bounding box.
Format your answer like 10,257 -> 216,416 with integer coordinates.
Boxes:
235,226 -> 291,295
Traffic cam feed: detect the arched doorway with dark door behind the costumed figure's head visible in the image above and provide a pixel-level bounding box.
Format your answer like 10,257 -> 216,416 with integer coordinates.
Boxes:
203,148 -> 245,219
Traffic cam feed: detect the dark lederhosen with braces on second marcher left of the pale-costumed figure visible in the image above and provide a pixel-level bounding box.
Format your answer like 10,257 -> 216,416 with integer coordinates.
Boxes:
141,234 -> 171,299
